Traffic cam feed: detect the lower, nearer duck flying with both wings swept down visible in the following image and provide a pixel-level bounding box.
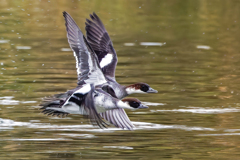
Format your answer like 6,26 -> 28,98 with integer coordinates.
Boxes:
41,84 -> 148,130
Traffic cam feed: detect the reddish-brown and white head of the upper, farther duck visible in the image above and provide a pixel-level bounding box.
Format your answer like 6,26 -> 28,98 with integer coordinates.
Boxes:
126,83 -> 158,94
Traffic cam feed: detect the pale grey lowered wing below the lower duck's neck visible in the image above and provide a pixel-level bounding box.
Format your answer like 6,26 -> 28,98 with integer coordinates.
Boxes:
100,108 -> 134,130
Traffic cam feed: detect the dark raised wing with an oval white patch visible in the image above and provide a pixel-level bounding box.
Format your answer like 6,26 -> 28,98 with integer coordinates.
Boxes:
85,13 -> 117,79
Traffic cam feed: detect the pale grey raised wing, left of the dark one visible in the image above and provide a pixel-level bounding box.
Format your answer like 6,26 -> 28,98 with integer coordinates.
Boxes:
63,12 -> 106,86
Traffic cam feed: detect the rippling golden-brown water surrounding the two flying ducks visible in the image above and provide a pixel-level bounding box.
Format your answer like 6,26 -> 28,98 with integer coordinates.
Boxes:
0,0 -> 240,160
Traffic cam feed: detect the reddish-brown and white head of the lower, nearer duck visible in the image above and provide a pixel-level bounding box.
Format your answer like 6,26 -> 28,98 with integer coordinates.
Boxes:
118,98 -> 148,109
